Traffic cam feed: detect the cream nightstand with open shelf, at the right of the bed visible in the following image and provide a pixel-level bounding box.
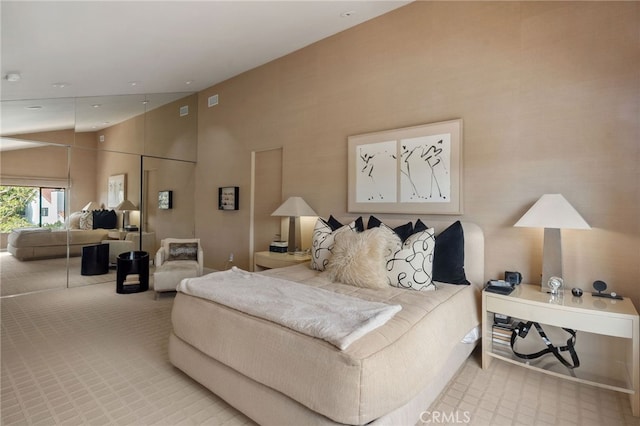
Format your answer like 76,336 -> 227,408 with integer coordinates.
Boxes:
482,284 -> 640,416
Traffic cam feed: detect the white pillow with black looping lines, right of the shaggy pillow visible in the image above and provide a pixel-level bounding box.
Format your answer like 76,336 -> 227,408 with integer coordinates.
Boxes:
386,228 -> 436,291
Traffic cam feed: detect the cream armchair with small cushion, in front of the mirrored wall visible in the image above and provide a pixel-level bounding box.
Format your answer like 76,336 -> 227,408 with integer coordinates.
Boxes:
153,238 -> 204,296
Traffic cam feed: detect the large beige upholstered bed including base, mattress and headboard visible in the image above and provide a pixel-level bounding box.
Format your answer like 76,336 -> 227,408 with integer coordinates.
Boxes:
169,220 -> 484,425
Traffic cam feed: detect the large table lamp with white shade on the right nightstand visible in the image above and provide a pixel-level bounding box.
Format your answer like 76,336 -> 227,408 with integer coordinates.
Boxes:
513,194 -> 591,291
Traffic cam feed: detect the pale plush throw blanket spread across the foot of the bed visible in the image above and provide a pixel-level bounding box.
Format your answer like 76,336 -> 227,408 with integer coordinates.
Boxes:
178,267 -> 402,350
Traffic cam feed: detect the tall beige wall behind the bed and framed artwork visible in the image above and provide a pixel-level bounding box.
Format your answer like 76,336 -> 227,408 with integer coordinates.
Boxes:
196,2 -> 640,306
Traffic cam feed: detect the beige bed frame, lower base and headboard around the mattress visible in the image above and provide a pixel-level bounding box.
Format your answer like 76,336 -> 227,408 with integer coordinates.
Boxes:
169,218 -> 484,426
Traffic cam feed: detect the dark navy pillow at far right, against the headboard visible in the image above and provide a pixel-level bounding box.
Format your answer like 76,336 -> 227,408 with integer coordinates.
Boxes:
433,221 -> 470,284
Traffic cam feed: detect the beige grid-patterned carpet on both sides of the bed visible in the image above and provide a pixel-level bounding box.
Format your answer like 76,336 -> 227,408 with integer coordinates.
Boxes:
0,283 -> 640,425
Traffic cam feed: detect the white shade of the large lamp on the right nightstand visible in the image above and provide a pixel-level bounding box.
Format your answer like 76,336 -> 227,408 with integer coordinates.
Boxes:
513,194 -> 591,229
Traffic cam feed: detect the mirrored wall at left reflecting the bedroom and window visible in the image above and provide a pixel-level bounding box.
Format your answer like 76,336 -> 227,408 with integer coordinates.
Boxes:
0,93 -> 197,296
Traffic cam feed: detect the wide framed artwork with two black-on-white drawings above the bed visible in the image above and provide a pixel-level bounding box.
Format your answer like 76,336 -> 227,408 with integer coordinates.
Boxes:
348,119 -> 463,215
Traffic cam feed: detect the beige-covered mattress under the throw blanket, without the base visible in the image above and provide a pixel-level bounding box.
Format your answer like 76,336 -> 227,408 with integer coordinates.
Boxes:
172,264 -> 479,424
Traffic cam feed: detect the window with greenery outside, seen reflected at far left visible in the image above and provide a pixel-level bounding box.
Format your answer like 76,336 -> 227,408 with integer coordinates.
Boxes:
0,186 -> 65,232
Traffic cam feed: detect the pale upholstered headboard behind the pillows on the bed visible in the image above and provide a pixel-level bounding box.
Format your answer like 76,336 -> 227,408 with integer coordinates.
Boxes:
330,214 -> 485,288
